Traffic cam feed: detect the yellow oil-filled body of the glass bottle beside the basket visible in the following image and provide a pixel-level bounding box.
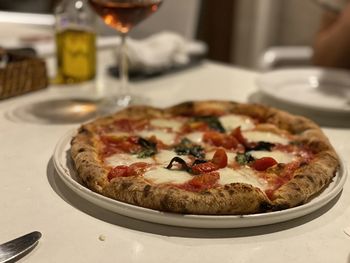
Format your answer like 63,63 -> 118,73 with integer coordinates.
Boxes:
56,29 -> 96,83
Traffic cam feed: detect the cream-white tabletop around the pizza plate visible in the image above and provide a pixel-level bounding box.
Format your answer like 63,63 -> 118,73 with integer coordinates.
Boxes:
0,46 -> 350,263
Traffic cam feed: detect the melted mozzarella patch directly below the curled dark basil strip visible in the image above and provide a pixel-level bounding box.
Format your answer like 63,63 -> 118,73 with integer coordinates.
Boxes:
144,167 -> 193,184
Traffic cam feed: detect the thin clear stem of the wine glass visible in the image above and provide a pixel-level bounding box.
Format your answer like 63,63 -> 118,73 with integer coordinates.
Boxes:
119,33 -> 130,104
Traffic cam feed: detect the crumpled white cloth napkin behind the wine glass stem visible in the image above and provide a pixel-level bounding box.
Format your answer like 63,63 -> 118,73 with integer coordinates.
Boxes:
117,32 -> 207,72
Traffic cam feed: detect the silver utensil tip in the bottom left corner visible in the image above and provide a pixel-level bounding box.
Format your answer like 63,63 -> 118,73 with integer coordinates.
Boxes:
0,231 -> 41,263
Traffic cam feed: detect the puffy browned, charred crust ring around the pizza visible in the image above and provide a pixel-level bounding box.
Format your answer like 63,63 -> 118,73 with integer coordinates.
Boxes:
71,101 -> 339,215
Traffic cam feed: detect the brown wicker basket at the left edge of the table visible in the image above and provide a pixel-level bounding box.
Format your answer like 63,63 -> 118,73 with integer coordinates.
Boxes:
0,52 -> 48,99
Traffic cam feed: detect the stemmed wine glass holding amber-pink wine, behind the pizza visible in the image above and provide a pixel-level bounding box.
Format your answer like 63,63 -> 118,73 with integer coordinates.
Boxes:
89,0 -> 163,112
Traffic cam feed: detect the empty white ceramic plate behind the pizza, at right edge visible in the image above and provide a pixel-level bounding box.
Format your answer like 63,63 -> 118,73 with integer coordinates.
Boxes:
257,68 -> 350,114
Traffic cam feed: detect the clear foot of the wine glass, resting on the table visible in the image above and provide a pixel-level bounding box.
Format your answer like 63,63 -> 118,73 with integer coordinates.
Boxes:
98,94 -> 149,116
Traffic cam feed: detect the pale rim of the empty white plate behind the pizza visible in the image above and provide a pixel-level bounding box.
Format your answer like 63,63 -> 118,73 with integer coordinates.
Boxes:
255,67 -> 350,114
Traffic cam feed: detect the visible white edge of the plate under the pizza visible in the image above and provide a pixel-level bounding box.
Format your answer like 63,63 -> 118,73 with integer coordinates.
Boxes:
53,132 -> 346,228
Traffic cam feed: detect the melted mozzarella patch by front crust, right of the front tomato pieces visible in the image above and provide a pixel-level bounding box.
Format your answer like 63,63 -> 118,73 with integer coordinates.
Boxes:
219,167 -> 267,190
